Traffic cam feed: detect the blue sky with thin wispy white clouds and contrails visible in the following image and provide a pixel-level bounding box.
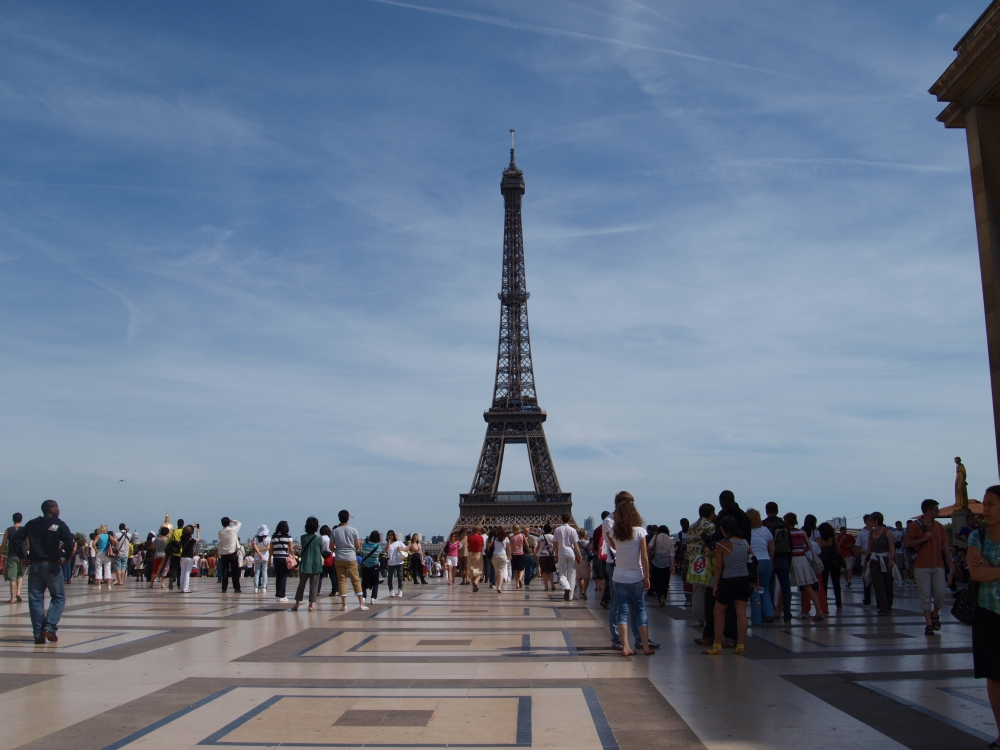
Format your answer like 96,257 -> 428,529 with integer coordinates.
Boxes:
0,0 -> 997,533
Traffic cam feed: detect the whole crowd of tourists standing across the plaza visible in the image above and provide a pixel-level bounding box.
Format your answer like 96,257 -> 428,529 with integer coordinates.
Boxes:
0,486 -> 1000,750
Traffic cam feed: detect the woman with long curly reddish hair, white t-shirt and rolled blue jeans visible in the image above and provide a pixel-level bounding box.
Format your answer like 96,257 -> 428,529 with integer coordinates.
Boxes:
608,493 -> 655,656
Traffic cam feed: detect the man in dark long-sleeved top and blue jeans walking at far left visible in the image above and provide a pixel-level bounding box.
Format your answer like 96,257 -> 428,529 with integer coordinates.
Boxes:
13,500 -> 73,645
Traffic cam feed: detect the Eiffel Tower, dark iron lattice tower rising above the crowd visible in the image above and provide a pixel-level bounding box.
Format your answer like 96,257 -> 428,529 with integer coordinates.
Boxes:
454,135 -> 576,530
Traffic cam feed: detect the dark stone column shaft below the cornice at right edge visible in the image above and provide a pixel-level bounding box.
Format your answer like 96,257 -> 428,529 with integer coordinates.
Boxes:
965,104 -> 1000,473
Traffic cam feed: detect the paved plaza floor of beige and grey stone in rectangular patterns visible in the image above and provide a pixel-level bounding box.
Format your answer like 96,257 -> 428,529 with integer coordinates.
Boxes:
0,580 -> 995,750
